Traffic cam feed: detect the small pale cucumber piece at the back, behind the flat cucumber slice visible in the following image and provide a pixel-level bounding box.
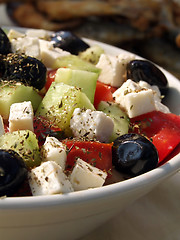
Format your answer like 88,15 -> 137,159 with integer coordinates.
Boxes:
79,45 -> 104,65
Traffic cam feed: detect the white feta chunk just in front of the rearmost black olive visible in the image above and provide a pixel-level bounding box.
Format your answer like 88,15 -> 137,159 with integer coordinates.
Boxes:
39,40 -> 70,68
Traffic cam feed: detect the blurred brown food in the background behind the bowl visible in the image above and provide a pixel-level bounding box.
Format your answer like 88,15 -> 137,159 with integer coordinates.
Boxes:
5,0 -> 180,78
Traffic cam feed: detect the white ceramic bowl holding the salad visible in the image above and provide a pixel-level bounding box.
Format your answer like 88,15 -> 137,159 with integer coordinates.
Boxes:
0,31 -> 180,240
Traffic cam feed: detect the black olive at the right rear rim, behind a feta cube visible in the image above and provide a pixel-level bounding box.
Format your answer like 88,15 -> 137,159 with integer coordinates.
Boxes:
127,60 -> 168,93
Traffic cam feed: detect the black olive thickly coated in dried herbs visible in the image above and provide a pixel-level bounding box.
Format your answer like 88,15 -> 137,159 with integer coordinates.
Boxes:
0,53 -> 47,90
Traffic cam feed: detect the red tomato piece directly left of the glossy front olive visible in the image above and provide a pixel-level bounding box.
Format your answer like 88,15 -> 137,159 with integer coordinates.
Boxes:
63,139 -> 112,176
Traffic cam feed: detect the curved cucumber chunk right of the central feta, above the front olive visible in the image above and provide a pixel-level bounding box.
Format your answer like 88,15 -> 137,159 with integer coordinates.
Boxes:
97,101 -> 129,142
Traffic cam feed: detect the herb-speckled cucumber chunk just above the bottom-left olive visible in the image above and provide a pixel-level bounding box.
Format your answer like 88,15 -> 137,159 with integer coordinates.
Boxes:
0,130 -> 41,168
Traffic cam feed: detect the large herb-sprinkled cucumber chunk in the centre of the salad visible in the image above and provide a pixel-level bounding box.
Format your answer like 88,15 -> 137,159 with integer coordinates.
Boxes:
36,82 -> 94,136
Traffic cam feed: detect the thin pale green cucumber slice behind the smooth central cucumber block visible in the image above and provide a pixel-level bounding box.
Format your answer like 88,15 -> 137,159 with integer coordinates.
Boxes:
52,55 -> 101,74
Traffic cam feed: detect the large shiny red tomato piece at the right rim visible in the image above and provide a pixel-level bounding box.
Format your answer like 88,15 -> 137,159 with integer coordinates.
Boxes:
131,111 -> 180,164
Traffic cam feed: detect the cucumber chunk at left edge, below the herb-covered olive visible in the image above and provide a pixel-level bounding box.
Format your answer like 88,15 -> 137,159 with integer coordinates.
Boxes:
0,83 -> 42,119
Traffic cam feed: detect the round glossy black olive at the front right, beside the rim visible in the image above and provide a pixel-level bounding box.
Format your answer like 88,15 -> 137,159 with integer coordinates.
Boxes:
112,133 -> 159,177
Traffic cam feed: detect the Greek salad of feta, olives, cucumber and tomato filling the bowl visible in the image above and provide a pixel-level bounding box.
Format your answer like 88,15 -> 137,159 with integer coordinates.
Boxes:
0,29 -> 180,197
